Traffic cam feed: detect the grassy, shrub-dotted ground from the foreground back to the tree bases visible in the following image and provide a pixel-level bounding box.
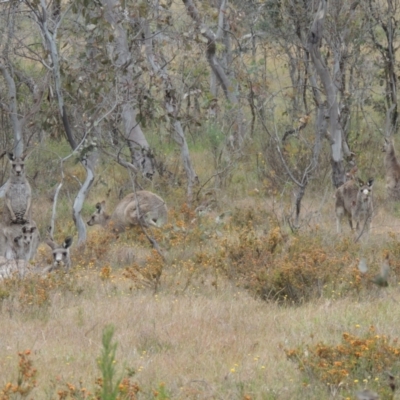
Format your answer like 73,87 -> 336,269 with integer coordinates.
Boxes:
0,137 -> 400,399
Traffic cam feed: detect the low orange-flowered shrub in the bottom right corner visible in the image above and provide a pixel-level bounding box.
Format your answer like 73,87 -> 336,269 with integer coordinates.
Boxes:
285,326 -> 400,399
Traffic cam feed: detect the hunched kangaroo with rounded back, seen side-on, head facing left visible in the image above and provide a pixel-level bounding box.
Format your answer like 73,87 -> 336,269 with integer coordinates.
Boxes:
87,190 -> 168,233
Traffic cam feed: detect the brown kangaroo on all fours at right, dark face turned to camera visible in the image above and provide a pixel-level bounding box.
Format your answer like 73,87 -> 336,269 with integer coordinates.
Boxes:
335,178 -> 374,233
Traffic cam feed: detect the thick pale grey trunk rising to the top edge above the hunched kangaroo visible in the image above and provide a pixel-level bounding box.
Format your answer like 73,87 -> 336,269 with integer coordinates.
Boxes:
102,0 -> 154,178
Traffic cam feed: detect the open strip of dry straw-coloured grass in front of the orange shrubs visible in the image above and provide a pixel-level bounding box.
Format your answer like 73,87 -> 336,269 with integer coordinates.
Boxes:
0,272 -> 400,399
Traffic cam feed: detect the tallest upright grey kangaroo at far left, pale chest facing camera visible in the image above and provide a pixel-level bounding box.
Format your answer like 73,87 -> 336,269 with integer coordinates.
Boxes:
3,153 -> 32,226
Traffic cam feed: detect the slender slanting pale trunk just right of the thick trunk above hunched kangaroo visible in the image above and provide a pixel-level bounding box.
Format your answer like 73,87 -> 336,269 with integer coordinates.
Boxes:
142,20 -> 198,204
